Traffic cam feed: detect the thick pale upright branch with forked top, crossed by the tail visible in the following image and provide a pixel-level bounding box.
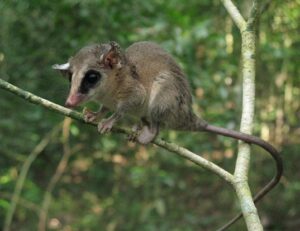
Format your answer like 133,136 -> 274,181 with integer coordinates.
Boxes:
220,0 -> 263,231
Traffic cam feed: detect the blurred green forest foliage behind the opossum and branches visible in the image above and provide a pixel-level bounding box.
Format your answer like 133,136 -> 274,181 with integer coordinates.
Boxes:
0,0 -> 300,231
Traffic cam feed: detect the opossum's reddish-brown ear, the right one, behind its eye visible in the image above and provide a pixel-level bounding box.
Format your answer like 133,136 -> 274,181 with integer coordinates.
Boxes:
102,42 -> 122,69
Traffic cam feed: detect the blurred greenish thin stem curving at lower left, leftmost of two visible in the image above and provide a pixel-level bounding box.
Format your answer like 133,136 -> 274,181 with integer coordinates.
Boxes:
3,126 -> 59,231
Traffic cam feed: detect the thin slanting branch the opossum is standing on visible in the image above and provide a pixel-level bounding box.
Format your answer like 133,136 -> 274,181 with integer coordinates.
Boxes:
0,78 -> 233,183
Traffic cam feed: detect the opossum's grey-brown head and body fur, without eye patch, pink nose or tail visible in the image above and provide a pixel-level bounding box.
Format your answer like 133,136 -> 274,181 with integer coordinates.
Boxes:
55,42 -> 206,143
